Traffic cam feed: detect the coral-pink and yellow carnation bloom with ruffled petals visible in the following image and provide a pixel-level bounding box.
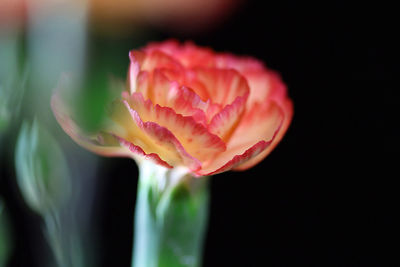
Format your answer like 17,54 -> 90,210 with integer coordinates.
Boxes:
52,41 -> 293,176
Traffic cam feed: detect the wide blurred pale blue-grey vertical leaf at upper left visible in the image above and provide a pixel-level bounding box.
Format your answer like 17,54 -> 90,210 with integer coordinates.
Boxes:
24,0 -> 87,122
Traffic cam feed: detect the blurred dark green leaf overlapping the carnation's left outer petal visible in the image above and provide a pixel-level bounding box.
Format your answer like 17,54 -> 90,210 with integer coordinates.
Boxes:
71,35 -> 136,132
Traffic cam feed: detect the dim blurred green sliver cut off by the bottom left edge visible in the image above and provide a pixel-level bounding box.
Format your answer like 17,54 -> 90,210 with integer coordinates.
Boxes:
0,199 -> 12,267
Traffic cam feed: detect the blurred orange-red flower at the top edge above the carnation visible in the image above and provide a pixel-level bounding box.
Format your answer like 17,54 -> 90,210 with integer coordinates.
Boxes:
89,0 -> 242,32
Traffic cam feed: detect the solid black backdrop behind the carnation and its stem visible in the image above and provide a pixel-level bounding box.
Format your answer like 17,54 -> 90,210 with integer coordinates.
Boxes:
0,1 -> 398,266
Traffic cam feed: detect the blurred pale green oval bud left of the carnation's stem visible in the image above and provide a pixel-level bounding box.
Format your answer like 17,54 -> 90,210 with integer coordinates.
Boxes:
15,120 -> 70,214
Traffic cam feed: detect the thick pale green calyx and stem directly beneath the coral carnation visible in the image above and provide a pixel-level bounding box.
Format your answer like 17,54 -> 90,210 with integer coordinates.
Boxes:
132,161 -> 209,267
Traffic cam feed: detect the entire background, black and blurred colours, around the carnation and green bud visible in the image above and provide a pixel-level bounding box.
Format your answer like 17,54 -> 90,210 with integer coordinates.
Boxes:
0,0 -> 399,267
